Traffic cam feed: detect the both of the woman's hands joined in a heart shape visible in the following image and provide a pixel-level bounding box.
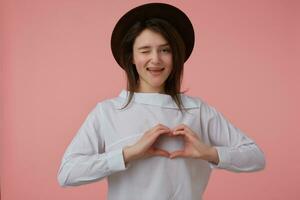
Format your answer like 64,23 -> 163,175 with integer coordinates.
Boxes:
123,124 -> 219,164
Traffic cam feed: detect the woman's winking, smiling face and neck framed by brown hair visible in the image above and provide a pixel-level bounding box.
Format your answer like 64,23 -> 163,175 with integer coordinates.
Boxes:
133,29 -> 173,93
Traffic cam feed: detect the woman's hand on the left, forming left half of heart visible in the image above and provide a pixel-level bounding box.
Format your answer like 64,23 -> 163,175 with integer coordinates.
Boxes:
123,124 -> 171,164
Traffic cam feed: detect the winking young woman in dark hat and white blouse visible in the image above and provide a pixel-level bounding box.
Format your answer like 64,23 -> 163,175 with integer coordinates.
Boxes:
58,3 -> 265,200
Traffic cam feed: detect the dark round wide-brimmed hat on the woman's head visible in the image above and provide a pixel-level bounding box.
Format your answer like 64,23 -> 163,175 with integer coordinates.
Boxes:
111,3 -> 195,67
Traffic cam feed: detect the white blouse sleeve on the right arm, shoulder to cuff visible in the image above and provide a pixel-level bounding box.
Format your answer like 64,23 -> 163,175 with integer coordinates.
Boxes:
200,101 -> 265,172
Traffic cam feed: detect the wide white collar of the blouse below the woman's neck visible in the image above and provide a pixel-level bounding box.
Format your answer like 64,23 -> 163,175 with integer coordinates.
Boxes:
119,89 -> 199,108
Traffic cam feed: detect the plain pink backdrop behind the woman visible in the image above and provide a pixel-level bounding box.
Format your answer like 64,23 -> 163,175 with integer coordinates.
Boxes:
0,0 -> 300,200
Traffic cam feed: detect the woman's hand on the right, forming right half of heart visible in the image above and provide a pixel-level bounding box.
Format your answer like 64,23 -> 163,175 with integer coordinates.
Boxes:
170,124 -> 219,164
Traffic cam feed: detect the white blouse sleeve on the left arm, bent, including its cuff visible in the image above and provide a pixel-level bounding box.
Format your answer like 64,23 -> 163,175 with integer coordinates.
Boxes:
57,104 -> 126,186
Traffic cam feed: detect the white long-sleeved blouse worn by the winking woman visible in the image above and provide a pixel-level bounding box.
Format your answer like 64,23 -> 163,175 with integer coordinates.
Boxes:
58,90 -> 265,200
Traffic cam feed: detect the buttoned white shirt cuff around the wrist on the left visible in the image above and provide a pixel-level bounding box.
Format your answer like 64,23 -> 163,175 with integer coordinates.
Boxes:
107,149 -> 128,172
